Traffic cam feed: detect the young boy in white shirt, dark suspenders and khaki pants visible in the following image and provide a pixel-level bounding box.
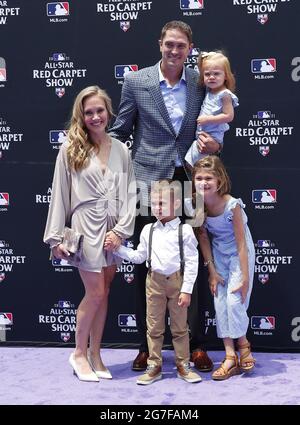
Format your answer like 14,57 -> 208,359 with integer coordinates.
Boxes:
116,180 -> 201,385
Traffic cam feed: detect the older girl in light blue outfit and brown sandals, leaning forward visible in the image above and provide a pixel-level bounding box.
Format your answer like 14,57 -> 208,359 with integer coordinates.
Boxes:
193,156 -> 255,380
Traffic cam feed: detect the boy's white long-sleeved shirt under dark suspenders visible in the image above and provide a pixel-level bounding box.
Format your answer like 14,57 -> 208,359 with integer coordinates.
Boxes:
115,217 -> 198,294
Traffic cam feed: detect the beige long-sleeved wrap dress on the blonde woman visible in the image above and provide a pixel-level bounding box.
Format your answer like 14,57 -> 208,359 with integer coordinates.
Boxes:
44,138 -> 136,272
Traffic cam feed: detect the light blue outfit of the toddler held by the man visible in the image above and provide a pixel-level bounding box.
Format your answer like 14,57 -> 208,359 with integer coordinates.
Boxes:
185,89 -> 239,166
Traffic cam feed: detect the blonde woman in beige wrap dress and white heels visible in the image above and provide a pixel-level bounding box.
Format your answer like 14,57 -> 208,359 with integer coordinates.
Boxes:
44,86 -> 136,382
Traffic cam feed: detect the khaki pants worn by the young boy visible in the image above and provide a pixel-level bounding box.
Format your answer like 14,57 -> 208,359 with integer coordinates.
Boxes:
146,271 -> 190,366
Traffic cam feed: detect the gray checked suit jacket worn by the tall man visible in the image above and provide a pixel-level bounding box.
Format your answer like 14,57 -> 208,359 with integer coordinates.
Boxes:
109,64 -> 203,184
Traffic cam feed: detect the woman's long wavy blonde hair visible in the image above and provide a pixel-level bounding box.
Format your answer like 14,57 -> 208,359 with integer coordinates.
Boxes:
67,86 -> 113,171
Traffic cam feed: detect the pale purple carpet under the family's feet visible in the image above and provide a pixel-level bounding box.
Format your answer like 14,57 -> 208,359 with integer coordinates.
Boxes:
0,347 -> 300,405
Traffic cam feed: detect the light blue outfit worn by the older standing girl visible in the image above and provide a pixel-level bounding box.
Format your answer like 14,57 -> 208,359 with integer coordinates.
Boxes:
204,197 -> 255,339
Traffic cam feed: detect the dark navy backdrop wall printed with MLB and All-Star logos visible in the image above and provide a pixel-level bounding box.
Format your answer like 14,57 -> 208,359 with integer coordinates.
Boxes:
0,0 -> 300,351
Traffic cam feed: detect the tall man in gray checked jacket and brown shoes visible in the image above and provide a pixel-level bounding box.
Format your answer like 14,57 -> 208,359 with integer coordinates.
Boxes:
110,21 -> 220,371
